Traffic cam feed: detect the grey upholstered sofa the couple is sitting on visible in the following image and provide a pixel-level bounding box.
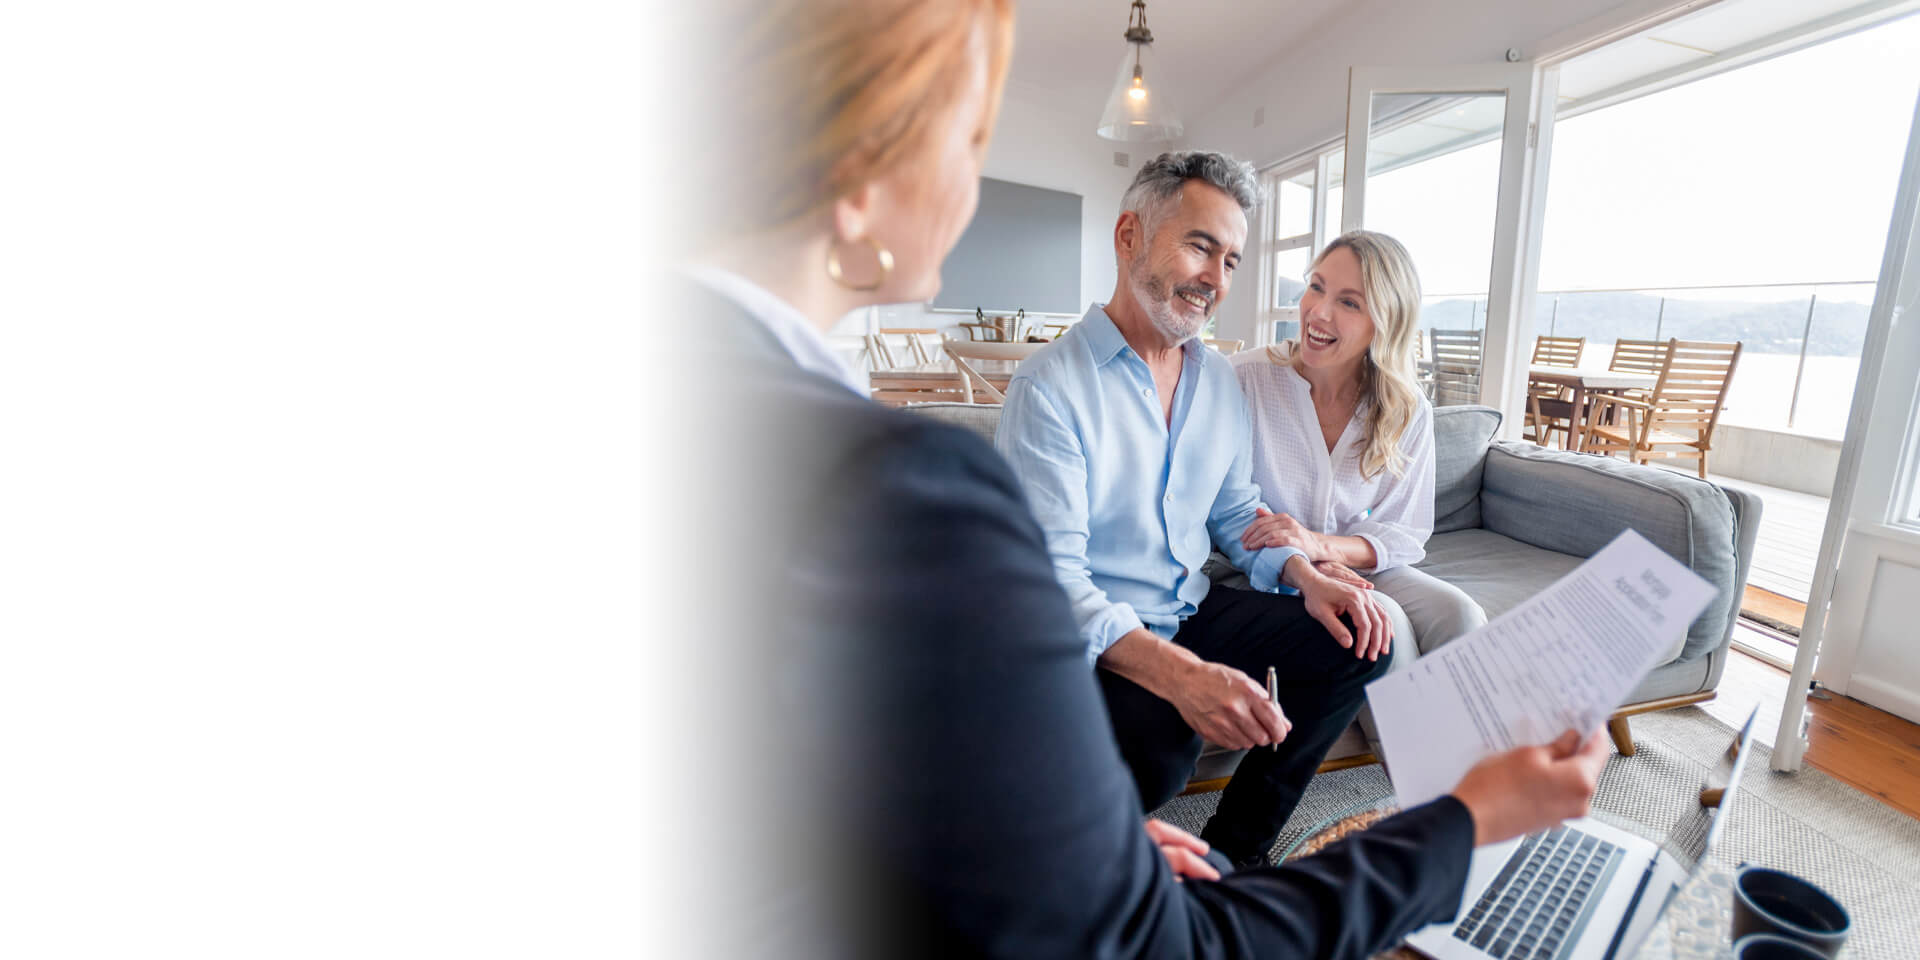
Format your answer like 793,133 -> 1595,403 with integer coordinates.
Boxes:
904,403 -> 1761,775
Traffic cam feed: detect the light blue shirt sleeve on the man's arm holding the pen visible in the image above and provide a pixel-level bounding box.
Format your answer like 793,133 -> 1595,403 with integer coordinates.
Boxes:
993,378 -> 1144,664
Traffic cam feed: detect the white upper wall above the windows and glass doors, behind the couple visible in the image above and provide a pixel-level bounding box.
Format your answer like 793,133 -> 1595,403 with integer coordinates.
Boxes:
1183,0 -> 1658,340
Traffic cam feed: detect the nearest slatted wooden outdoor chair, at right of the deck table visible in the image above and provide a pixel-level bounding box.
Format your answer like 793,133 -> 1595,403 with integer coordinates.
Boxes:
1586,338 -> 1740,480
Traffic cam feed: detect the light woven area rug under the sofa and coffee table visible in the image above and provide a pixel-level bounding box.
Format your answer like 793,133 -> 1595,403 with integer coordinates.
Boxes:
1154,707 -> 1920,960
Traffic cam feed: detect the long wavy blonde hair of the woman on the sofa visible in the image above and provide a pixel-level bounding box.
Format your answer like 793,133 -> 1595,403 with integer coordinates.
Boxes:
1267,230 -> 1423,480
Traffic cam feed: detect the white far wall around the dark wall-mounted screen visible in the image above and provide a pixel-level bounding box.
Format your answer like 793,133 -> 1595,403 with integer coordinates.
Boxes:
833,83 -> 1167,336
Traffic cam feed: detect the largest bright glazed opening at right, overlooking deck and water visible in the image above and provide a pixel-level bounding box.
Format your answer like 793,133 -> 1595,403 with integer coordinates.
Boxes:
1534,17 -> 1920,440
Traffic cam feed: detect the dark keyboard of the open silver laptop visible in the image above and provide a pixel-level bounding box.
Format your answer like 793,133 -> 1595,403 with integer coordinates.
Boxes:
1453,828 -> 1620,960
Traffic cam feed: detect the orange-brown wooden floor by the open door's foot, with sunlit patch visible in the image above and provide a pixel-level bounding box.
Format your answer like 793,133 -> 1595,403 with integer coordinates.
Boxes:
1705,651 -> 1920,820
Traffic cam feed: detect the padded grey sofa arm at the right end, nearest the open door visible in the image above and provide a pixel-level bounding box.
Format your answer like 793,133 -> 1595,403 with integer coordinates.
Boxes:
1482,442 -> 1743,662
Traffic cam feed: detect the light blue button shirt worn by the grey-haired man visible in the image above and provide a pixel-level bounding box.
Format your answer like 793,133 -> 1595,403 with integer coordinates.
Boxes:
995,303 -> 1300,662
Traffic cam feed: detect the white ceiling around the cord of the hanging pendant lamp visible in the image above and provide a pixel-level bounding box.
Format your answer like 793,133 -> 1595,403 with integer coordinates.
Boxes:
1008,0 -> 1344,132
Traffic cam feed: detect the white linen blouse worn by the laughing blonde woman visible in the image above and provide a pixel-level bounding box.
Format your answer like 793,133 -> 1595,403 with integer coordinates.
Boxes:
1233,346 -> 1434,572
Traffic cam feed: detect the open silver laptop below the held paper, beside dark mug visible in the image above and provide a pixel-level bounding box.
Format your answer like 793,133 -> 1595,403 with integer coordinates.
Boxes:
1407,707 -> 1759,960
